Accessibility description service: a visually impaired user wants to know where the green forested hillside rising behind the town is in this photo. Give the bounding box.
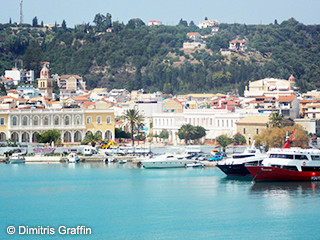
[0,14,320,94]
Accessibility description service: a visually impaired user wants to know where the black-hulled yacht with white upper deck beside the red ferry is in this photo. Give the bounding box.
[216,143,267,176]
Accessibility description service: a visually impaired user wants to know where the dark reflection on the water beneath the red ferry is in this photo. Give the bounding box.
[251,182,320,197]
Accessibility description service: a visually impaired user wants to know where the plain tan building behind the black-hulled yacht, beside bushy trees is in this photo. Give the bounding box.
[236,115,269,144]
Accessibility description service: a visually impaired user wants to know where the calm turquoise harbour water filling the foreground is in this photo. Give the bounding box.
[0,163,320,239]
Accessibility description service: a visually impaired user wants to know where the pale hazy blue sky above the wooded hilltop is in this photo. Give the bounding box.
[0,0,320,27]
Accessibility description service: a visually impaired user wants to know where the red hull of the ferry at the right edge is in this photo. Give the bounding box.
[246,166,320,181]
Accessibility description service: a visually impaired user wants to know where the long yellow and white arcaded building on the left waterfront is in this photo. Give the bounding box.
[0,108,114,143]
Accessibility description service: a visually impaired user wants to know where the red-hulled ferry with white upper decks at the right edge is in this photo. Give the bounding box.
[246,148,320,181]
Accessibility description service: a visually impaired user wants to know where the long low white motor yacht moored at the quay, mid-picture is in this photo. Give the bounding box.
[141,154,193,168]
